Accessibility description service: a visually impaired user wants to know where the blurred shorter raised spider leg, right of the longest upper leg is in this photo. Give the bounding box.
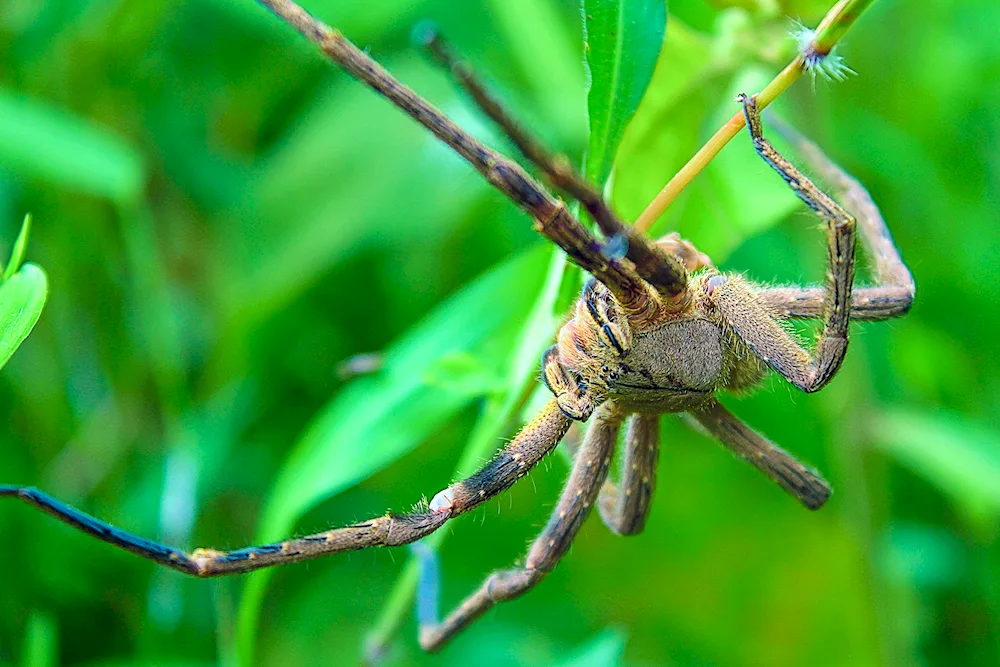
[418,24,687,297]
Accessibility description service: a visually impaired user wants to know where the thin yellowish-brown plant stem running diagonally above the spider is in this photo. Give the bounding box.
[635,0,874,232]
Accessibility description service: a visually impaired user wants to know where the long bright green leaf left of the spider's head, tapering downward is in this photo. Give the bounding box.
[237,246,550,662]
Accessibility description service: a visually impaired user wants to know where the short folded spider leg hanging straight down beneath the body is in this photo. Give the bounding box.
[597,414,660,535]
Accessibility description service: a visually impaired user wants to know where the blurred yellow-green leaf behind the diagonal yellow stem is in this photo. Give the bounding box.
[614,28,802,265]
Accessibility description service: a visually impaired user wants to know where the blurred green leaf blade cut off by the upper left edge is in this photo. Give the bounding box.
[0,89,145,201]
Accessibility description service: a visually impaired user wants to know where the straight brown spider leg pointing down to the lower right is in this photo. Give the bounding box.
[690,400,831,510]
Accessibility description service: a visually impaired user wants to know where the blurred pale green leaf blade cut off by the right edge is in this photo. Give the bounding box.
[872,410,1000,522]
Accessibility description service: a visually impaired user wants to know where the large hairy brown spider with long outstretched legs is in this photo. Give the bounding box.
[0,0,915,651]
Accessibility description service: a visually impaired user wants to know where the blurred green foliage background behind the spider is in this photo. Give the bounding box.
[0,0,1000,666]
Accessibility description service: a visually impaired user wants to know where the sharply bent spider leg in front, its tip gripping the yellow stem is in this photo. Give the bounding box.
[708,95,855,392]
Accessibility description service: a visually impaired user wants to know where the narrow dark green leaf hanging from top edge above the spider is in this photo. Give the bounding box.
[583,0,667,183]
